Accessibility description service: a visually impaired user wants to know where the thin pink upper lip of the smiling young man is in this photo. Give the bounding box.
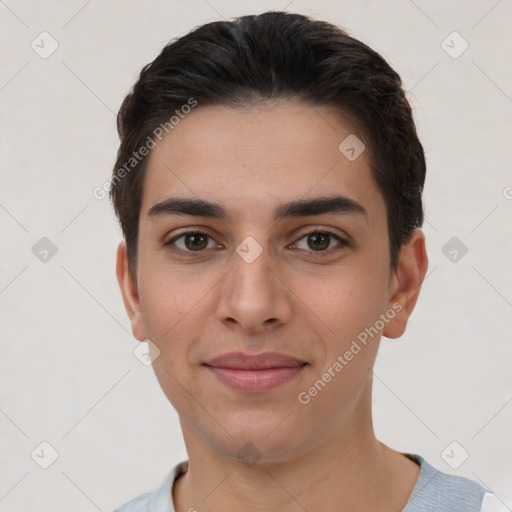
[205,352,305,370]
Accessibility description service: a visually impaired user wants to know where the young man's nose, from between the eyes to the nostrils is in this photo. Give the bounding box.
[217,243,292,335]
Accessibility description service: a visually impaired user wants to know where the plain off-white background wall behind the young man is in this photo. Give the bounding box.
[0,0,512,512]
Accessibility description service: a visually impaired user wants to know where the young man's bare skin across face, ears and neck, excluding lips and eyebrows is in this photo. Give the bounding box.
[117,101,427,512]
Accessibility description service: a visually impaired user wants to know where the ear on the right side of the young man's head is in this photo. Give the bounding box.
[382,229,428,338]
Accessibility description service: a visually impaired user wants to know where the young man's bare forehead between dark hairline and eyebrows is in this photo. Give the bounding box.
[141,101,385,224]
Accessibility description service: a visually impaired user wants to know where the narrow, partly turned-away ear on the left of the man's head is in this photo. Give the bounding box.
[116,240,147,341]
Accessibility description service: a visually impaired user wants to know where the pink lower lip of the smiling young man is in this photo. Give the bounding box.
[207,365,305,393]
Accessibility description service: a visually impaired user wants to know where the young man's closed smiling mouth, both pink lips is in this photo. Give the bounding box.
[204,352,308,393]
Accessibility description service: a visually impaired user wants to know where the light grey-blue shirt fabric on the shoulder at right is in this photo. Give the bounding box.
[403,455,487,512]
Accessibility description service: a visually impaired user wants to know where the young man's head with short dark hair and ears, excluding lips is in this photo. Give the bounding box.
[111,12,427,466]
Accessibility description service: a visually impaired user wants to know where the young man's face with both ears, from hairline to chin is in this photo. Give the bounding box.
[118,102,426,461]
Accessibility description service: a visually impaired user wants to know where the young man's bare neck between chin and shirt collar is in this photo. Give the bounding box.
[173,380,419,512]
